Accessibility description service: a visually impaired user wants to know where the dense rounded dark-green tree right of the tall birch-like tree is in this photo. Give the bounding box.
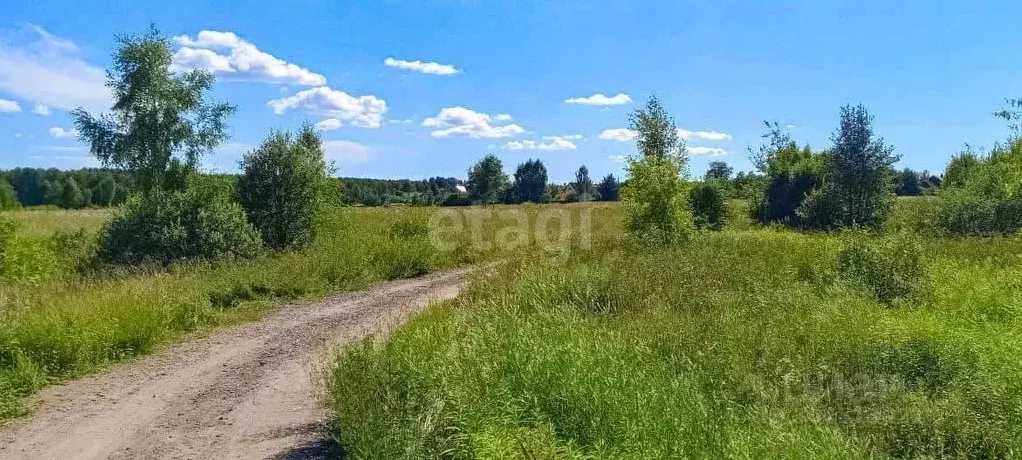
[238,125,327,249]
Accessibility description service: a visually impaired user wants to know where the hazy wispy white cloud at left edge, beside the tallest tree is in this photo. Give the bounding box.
[0,25,112,111]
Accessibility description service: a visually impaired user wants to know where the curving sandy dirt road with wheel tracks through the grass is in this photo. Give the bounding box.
[0,271,466,459]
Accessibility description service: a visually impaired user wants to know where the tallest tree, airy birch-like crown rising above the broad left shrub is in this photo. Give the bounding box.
[72,27,234,193]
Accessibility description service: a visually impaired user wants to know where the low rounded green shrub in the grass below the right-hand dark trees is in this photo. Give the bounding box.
[837,235,925,305]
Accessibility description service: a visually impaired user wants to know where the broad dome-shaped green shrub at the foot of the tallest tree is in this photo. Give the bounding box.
[99,182,262,265]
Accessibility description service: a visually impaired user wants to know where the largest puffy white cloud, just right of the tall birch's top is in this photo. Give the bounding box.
[173,31,326,86]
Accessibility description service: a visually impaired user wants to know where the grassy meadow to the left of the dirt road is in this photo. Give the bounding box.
[0,206,599,420]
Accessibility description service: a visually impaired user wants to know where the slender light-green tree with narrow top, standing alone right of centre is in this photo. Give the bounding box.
[621,97,692,245]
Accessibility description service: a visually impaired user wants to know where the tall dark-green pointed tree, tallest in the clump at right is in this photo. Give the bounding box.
[800,105,898,229]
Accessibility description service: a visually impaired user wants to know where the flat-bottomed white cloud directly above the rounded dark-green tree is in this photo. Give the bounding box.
[267,86,386,128]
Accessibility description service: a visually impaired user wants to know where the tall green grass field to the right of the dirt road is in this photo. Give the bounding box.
[329,201,1022,459]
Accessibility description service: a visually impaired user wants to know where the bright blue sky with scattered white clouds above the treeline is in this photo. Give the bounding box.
[0,0,1022,181]
